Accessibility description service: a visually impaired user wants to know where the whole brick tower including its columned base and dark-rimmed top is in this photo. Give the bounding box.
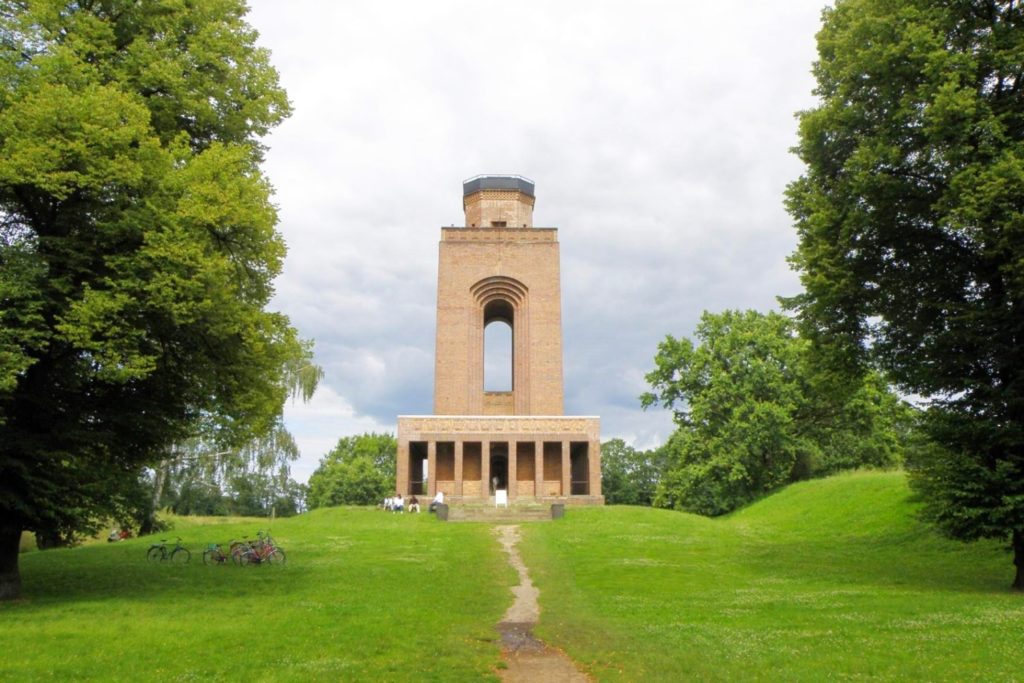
[396,175,603,504]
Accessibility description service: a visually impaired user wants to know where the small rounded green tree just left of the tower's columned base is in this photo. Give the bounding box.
[307,433,398,509]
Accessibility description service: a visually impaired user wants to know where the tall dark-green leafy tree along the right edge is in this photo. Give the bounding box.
[787,0,1024,589]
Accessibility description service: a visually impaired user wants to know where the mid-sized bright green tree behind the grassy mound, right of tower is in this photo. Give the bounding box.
[641,311,908,515]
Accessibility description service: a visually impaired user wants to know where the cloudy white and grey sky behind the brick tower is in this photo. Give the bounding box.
[249,0,825,481]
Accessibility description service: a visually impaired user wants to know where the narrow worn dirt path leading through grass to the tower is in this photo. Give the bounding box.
[495,524,590,683]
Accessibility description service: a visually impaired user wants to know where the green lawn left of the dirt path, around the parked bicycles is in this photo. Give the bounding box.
[0,508,515,682]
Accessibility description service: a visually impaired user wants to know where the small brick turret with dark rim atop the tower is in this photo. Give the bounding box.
[462,175,536,227]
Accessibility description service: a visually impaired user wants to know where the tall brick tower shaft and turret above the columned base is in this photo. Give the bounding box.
[434,171,562,415]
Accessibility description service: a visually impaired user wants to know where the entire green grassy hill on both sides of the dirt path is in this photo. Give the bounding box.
[0,473,1024,682]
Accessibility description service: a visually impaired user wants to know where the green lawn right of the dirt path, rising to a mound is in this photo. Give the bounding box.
[523,473,1024,681]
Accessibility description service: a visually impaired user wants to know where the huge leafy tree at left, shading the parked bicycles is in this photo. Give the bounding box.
[0,0,303,598]
